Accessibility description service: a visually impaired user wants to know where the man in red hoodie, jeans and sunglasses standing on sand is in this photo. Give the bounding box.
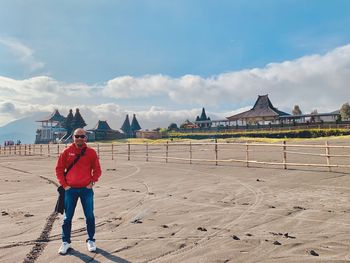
[56,129,101,255]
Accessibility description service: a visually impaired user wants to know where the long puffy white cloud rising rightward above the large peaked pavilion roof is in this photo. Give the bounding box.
[100,45,350,111]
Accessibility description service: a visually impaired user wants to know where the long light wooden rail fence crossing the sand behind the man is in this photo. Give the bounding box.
[0,141,350,171]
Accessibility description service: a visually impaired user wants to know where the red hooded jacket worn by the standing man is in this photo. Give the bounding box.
[56,143,101,188]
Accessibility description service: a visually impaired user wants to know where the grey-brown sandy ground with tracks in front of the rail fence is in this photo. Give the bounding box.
[0,141,350,263]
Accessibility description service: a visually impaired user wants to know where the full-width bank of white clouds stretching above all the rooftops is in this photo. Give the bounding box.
[0,45,350,129]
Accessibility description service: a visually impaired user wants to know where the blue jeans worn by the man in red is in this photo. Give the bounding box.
[62,187,95,243]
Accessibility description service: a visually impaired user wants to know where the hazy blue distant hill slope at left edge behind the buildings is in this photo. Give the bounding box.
[0,112,50,145]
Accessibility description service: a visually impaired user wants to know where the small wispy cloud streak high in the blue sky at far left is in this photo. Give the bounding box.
[0,37,45,72]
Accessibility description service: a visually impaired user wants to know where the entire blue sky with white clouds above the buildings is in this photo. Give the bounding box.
[0,0,350,129]
